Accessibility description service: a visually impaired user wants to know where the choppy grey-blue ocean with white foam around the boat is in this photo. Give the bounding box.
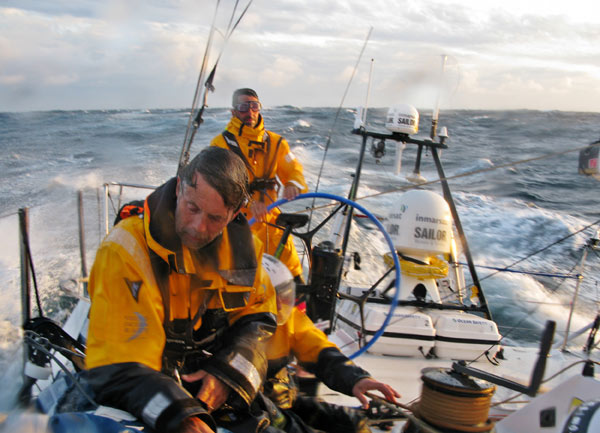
[0,106,600,408]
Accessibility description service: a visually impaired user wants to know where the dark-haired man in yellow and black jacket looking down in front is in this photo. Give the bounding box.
[86,148,276,433]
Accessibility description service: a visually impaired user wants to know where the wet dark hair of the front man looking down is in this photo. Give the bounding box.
[179,146,248,211]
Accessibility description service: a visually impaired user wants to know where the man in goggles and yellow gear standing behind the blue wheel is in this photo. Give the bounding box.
[210,88,308,277]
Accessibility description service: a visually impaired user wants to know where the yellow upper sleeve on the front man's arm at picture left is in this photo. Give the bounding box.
[85,228,166,370]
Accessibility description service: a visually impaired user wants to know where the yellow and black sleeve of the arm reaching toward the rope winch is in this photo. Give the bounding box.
[289,309,371,395]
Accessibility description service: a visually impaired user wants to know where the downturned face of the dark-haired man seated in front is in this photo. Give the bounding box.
[175,173,236,249]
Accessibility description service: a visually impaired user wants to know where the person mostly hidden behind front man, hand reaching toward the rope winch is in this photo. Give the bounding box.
[262,254,400,433]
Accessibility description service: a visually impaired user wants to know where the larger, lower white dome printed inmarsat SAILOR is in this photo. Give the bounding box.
[386,190,453,261]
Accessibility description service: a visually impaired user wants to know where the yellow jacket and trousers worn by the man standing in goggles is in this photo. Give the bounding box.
[210,115,308,276]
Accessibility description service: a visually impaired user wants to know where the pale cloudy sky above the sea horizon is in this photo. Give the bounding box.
[0,0,600,112]
